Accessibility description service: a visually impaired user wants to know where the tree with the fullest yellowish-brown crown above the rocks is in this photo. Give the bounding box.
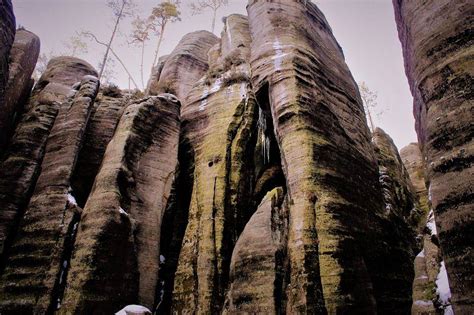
[149,0,181,71]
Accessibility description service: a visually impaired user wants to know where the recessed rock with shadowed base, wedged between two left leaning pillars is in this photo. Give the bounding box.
[71,92,129,207]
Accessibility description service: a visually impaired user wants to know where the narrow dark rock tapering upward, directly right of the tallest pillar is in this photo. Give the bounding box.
[372,128,424,314]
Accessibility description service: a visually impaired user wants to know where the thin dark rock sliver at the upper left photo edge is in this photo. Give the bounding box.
[0,0,16,142]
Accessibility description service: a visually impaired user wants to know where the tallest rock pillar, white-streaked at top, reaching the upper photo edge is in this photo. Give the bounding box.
[247,1,387,314]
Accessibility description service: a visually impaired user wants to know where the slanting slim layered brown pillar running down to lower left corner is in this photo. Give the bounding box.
[0,76,99,314]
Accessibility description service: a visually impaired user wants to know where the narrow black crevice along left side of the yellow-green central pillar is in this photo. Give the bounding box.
[154,137,194,314]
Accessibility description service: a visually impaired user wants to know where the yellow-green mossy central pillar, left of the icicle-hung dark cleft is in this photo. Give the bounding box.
[171,17,257,314]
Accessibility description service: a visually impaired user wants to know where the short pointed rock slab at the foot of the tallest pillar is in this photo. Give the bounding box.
[223,187,288,314]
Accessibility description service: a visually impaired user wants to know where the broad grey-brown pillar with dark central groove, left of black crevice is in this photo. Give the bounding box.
[60,94,179,314]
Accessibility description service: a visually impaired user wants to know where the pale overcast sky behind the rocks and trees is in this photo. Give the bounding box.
[13,0,416,149]
